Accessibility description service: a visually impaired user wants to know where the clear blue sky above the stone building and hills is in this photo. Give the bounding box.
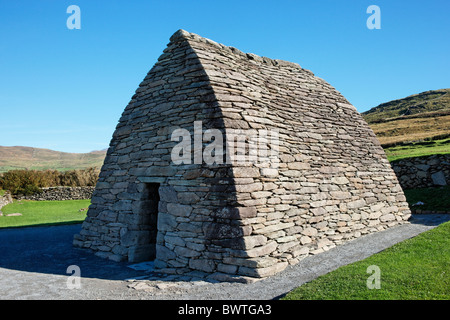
[0,0,450,152]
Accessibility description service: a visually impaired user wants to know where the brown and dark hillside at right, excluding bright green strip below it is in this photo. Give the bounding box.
[362,89,450,147]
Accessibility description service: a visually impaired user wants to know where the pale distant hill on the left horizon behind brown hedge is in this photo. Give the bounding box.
[0,146,106,172]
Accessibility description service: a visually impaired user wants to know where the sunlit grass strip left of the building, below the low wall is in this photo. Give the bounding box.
[0,200,91,228]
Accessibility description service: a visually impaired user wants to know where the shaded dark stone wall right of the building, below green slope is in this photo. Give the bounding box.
[391,154,450,189]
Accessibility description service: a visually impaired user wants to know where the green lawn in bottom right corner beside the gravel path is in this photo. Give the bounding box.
[283,222,450,300]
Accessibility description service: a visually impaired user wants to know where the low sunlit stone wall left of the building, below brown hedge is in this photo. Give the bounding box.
[16,187,95,201]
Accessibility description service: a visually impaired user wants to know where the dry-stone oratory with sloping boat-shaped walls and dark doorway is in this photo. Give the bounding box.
[73,30,410,281]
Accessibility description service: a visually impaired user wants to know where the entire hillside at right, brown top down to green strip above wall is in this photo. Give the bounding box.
[362,89,450,161]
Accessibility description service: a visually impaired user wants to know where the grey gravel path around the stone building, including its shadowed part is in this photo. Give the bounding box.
[0,215,450,300]
